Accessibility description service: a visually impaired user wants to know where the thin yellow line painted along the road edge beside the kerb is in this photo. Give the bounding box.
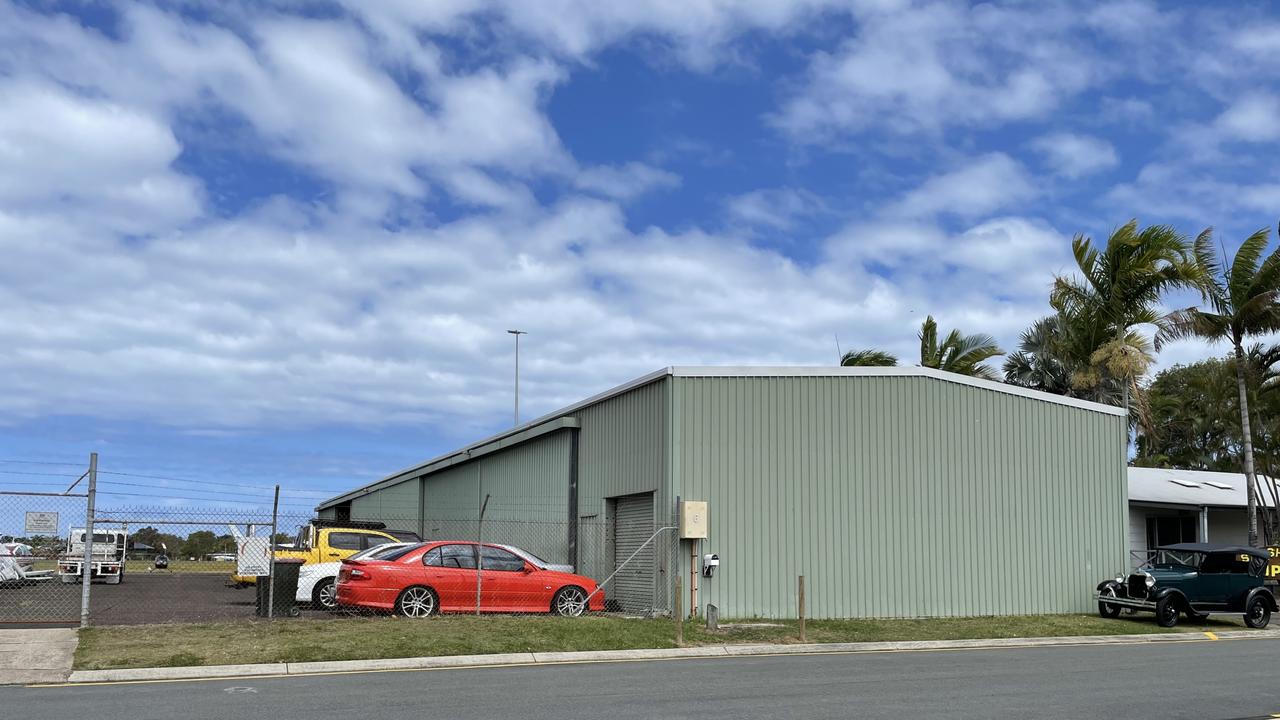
[32,637,1280,686]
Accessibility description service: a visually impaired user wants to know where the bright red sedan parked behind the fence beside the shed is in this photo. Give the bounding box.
[338,541,604,618]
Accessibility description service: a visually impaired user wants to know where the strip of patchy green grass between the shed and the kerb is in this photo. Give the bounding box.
[76,607,1243,670]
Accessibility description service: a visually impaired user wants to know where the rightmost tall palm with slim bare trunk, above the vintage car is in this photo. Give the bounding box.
[1156,228,1280,546]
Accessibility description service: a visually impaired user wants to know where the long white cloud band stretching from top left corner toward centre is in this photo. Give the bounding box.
[0,5,572,210]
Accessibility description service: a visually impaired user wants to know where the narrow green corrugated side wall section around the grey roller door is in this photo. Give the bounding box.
[573,378,673,593]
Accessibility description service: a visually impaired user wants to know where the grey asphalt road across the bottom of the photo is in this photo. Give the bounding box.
[0,639,1280,720]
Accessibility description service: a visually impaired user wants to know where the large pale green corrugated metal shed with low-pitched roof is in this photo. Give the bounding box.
[319,368,1126,618]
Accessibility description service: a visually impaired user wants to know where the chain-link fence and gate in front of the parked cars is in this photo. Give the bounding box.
[0,481,680,625]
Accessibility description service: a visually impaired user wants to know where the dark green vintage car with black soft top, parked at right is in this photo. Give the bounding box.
[1097,542,1280,628]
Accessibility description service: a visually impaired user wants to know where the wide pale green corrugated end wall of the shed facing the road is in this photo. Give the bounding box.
[673,377,1126,618]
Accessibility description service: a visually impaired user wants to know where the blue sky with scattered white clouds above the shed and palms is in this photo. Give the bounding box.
[0,0,1280,509]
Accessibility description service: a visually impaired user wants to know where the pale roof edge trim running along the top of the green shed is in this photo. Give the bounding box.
[316,365,1125,510]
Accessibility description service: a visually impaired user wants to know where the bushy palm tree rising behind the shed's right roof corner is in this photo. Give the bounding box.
[1050,215,1204,409]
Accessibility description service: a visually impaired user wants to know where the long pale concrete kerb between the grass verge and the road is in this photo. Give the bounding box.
[68,630,1280,683]
